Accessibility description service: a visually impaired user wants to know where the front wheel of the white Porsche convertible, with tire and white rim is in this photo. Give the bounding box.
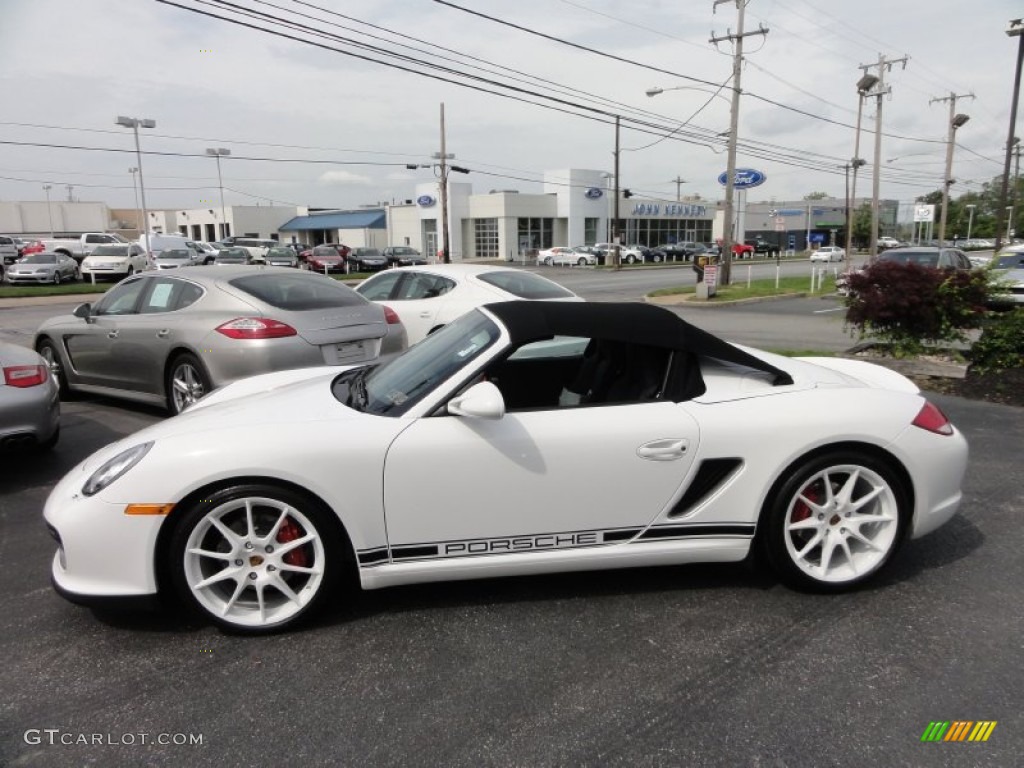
[169,484,348,634]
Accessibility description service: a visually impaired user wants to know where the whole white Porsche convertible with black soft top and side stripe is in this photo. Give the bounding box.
[44,302,968,633]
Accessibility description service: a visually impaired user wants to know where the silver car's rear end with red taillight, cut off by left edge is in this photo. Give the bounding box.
[0,341,60,453]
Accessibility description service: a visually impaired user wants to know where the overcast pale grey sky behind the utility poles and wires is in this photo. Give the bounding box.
[0,0,1024,217]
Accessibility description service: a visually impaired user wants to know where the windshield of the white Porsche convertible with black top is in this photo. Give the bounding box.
[346,310,501,416]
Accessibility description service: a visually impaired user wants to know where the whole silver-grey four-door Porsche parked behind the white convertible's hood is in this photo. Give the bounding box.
[34,266,408,414]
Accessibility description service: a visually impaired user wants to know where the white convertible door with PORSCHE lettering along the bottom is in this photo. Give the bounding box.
[384,401,699,561]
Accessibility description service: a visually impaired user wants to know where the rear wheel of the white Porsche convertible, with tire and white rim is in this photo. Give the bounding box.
[761,451,911,592]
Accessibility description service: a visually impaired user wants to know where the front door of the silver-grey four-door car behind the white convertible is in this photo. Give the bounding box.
[62,278,146,388]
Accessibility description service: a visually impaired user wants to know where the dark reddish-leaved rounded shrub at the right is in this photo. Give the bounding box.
[846,261,989,356]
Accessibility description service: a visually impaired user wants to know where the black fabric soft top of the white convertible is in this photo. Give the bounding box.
[486,301,793,386]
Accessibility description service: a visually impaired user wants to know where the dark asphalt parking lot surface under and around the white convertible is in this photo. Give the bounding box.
[0,278,1024,768]
